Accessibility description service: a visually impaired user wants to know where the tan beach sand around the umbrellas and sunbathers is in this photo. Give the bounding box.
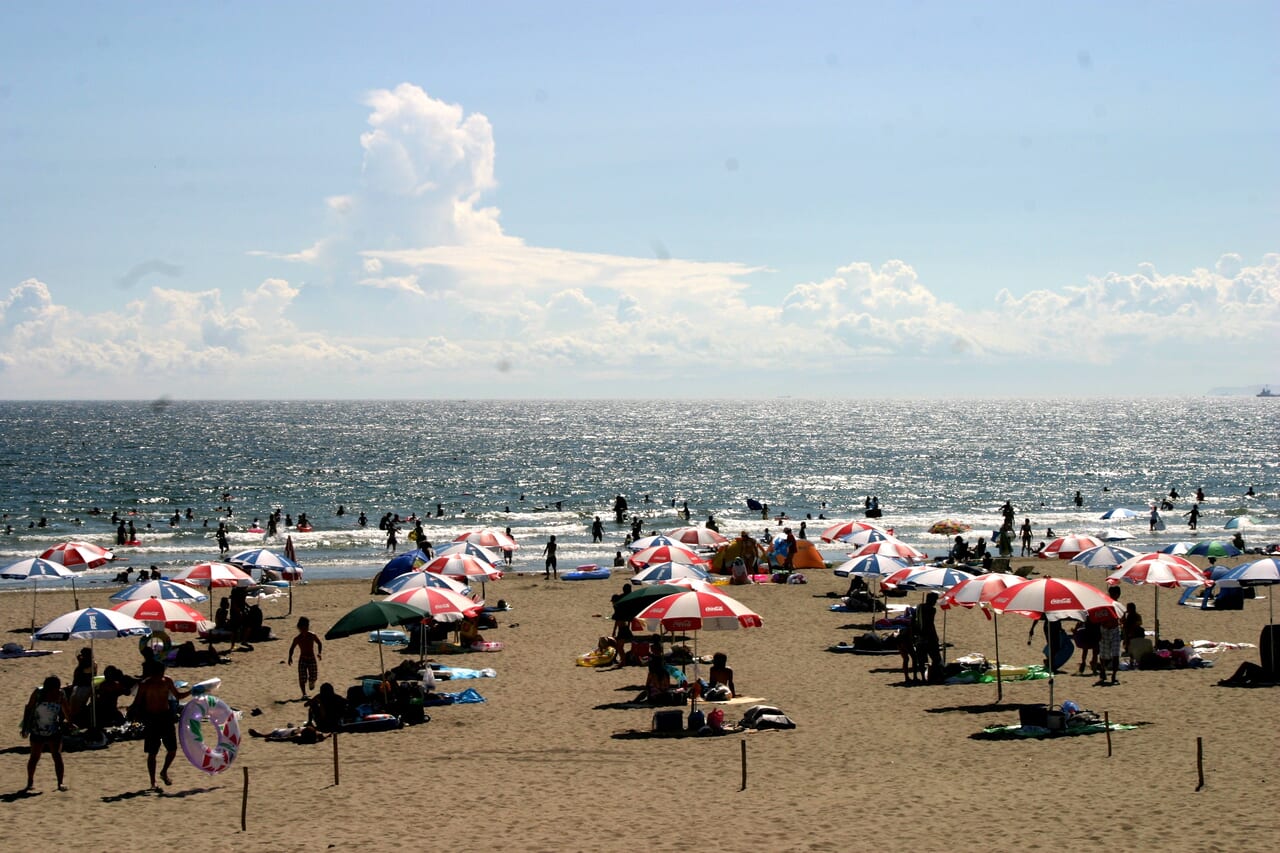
[0,561,1280,853]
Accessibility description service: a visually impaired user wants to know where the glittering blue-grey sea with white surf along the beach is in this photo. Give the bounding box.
[0,397,1280,589]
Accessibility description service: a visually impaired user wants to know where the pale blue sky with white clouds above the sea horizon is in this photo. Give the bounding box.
[0,0,1280,400]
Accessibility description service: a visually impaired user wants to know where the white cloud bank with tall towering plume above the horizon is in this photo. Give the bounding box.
[0,83,1280,398]
